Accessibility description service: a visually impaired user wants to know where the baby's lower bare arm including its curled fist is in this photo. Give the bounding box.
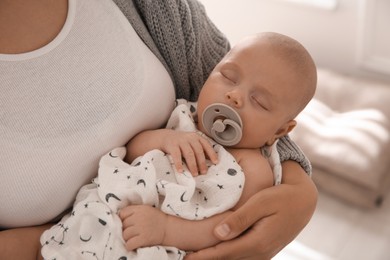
[119,205,231,251]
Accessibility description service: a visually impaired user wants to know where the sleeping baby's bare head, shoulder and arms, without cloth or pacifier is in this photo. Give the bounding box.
[120,32,317,250]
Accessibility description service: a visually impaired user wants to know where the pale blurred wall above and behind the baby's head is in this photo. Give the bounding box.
[201,0,390,82]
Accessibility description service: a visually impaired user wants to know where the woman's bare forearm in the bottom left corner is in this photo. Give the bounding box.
[0,224,52,260]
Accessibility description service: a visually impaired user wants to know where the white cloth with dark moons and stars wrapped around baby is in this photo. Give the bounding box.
[41,100,245,260]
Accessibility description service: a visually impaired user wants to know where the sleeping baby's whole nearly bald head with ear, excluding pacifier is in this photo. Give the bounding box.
[198,32,317,148]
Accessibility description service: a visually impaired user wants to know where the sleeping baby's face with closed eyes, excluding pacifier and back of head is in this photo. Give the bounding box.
[198,37,299,148]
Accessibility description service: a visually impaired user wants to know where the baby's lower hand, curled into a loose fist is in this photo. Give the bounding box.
[119,205,167,251]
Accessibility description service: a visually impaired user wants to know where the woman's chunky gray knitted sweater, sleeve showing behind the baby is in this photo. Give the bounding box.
[113,0,311,174]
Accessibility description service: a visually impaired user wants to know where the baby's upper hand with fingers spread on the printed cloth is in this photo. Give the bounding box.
[161,131,218,176]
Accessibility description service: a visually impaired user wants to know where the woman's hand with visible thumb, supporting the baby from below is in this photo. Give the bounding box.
[186,161,317,260]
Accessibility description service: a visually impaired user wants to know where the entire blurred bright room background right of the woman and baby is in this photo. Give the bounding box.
[201,0,390,260]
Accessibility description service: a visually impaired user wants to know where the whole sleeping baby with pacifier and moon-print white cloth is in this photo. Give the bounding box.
[41,32,316,259]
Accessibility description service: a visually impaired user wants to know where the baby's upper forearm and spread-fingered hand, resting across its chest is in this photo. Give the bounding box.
[125,129,218,176]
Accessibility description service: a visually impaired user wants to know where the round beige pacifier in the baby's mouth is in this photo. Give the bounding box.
[202,103,243,146]
